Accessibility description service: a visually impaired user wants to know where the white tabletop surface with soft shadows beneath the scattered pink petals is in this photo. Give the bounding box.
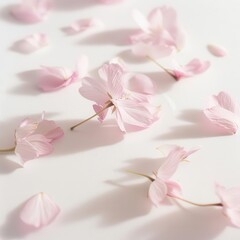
[0,0,240,240]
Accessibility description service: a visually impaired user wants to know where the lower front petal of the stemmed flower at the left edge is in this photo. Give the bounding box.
[15,134,53,164]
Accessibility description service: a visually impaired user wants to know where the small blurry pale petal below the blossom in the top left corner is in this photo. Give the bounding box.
[14,33,48,53]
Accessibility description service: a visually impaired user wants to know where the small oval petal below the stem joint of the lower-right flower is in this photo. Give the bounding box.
[148,178,167,207]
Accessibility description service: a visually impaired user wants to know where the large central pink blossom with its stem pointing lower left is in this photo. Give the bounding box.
[71,63,159,132]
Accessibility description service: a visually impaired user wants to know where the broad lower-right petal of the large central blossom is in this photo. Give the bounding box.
[112,100,159,132]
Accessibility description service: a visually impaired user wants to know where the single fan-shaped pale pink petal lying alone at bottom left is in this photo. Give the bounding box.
[20,193,60,228]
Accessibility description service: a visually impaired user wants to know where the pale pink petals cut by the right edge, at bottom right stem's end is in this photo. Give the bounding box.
[215,185,240,228]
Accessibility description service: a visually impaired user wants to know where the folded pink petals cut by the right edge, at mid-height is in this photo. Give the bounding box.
[204,92,240,134]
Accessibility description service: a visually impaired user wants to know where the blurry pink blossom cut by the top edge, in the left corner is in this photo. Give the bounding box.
[11,0,51,23]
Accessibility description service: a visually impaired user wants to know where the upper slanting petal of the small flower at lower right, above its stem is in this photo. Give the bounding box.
[157,146,199,180]
